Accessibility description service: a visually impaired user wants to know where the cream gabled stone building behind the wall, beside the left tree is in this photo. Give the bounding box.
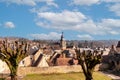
[19,49,49,67]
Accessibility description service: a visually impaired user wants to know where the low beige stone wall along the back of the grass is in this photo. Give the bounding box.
[18,64,106,76]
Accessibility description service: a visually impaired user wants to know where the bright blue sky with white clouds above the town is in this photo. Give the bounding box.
[0,0,120,40]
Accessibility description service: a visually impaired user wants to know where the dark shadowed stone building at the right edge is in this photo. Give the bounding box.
[103,41,120,72]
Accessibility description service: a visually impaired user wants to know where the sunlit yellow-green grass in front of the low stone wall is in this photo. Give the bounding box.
[23,72,112,80]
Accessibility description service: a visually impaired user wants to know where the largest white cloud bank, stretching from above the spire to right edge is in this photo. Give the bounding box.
[36,11,120,35]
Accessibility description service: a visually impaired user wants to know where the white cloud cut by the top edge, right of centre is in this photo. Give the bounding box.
[71,0,100,6]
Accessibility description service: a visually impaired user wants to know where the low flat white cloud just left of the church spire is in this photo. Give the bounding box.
[30,32,61,40]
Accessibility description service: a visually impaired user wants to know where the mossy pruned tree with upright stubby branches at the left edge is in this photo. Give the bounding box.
[0,40,30,80]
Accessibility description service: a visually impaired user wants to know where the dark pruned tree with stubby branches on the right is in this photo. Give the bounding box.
[75,49,103,80]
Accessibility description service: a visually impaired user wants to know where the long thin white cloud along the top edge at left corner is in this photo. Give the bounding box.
[0,0,58,7]
